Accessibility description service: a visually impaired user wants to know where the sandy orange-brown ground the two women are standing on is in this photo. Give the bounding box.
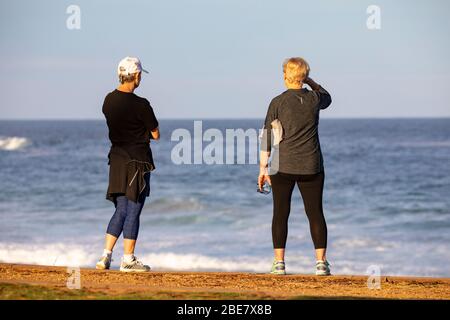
[0,264,450,300]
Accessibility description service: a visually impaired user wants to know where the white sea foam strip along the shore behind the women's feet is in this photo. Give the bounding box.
[0,243,445,276]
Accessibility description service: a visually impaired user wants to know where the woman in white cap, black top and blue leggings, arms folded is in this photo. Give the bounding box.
[96,57,159,272]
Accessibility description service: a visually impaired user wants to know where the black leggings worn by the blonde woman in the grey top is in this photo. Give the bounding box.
[270,171,327,249]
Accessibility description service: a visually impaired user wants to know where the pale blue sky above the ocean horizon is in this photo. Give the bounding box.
[0,0,450,119]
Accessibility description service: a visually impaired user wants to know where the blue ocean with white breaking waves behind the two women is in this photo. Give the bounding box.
[0,118,450,277]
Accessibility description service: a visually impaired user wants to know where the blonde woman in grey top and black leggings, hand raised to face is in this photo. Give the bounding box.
[258,58,331,275]
